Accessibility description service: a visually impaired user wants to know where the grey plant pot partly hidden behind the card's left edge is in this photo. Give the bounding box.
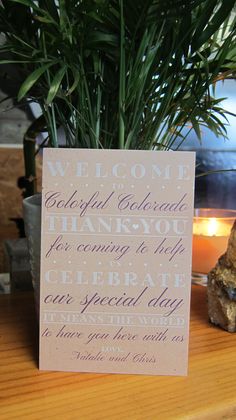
[23,194,42,315]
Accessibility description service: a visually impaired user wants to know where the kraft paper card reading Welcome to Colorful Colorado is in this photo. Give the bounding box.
[40,149,195,375]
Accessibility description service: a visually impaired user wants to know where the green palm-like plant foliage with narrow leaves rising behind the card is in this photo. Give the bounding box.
[0,0,236,302]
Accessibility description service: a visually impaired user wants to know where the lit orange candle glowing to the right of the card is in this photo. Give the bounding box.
[192,209,236,273]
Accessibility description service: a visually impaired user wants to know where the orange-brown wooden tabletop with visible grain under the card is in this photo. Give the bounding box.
[0,286,236,420]
